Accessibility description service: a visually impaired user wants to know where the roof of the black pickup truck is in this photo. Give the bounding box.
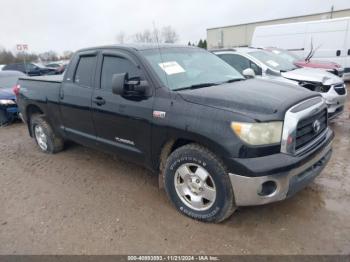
[77,43,198,52]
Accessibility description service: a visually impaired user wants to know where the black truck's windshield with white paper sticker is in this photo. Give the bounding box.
[141,48,244,90]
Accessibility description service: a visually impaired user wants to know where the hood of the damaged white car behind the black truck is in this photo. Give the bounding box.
[281,67,343,85]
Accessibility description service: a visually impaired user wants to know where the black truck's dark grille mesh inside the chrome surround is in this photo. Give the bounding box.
[295,109,327,151]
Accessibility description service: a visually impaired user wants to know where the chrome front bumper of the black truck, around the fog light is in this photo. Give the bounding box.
[229,142,332,206]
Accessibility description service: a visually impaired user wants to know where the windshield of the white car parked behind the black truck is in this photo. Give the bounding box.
[249,50,297,72]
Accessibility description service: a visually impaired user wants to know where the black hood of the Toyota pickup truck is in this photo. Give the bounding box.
[178,79,319,121]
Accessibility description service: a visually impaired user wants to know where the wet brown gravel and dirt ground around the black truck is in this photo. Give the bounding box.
[0,84,350,254]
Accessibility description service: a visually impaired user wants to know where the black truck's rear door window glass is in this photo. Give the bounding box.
[74,56,96,86]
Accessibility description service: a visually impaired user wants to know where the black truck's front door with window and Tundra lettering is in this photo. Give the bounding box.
[92,51,153,163]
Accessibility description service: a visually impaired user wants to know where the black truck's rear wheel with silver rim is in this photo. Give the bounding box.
[30,115,64,154]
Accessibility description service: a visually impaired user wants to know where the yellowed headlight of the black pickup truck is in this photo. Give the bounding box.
[231,122,283,146]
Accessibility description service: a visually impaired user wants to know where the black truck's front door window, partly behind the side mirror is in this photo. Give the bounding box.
[101,56,142,90]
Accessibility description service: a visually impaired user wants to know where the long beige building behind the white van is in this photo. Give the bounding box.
[207,9,350,49]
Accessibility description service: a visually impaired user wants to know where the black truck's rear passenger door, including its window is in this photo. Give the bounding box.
[60,52,97,145]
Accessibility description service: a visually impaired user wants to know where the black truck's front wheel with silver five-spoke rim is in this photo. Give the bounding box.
[164,144,236,223]
